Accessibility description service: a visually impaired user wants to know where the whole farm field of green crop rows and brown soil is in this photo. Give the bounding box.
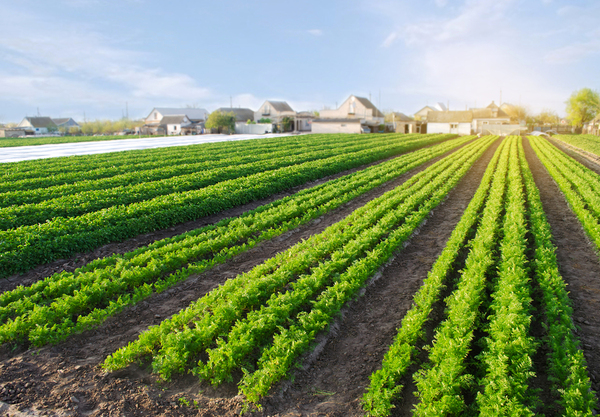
[0,135,600,416]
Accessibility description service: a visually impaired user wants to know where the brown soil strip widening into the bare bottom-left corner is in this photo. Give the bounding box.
[0,141,474,416]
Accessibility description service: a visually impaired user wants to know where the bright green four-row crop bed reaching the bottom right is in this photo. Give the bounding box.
[363,137,596,416]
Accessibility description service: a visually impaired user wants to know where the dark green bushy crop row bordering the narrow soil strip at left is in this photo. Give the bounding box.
[0,133,452,278]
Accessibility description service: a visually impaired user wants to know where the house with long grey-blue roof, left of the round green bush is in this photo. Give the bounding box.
[140,107,208,135]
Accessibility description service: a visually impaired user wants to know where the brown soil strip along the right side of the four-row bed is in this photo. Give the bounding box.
[523,140,600,402]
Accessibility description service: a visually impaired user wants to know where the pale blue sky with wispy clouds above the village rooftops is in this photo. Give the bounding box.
[0,0,600,123]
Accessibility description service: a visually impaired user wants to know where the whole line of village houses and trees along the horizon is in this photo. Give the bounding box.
[0,88,600,138]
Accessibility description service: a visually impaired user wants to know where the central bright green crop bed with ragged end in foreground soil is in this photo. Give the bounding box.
[104,138,495,401]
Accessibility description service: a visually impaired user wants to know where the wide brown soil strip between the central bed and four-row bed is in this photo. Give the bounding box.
[255,140,500,416]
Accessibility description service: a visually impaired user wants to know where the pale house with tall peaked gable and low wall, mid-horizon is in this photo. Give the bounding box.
[312,95,384,133]
